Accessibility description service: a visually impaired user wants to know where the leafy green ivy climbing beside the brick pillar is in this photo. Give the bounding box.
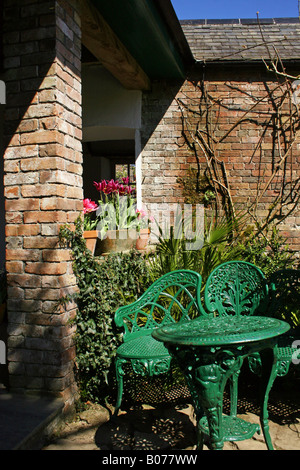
[60,219,148,402]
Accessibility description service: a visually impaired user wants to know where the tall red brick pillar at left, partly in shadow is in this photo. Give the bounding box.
[4,0,82,399]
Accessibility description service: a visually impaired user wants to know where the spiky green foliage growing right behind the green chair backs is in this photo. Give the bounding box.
[149,210,295,288]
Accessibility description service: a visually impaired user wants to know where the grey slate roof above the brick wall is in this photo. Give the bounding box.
[180,18,300,62]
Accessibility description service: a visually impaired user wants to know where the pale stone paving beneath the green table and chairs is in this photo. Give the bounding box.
[43,382,300,452]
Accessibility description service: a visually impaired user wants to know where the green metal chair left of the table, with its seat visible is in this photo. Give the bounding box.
[114,270,205,414]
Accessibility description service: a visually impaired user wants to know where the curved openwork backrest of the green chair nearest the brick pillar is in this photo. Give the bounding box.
[114,270,205,341]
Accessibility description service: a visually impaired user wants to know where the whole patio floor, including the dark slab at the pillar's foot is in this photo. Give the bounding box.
[0,376,300,452]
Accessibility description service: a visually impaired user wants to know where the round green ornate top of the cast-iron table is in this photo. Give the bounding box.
[152,315,290,346]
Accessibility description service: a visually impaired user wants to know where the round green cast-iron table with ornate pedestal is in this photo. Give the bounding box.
[152,316,290,450]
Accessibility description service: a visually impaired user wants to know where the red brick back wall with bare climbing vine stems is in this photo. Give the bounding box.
[142,69,300,251]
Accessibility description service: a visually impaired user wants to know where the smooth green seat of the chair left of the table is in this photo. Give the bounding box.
[117,334,170,359]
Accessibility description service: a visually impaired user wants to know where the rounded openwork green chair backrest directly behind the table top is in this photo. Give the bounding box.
[204,261,268,316]
